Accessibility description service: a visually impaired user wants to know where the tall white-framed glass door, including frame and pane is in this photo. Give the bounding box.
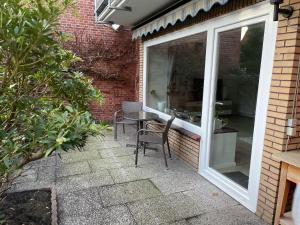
[200,8,276,212]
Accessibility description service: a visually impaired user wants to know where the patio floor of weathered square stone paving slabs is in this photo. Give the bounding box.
[10,128,264,225]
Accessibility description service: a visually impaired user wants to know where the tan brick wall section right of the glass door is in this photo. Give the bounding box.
[257,0,300,223]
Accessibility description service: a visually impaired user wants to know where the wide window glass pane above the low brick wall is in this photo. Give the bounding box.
[146,33,206,126]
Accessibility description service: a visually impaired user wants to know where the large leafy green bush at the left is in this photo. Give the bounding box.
[0,0,106,184]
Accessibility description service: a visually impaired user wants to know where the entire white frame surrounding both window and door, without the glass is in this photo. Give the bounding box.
[143,2,277,212]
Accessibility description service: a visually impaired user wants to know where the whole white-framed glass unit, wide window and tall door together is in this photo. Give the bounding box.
[143,3,276,211]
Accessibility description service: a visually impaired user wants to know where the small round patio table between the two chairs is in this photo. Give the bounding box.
[124,111,159,147]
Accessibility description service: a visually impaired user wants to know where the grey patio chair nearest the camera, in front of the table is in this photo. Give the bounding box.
[135,116,175,168]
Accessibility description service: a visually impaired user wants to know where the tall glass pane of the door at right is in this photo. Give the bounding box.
[210,23,264,188]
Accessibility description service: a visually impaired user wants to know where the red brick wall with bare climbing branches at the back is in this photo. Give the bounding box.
[60,0,137,120]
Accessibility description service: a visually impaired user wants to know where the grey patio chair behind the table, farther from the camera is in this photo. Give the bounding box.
[113,101,143,140]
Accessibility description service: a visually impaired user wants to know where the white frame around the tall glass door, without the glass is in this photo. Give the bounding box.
[199,3,277,212]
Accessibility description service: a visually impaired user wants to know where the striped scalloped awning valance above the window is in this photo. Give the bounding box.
[132,0,229,39]
